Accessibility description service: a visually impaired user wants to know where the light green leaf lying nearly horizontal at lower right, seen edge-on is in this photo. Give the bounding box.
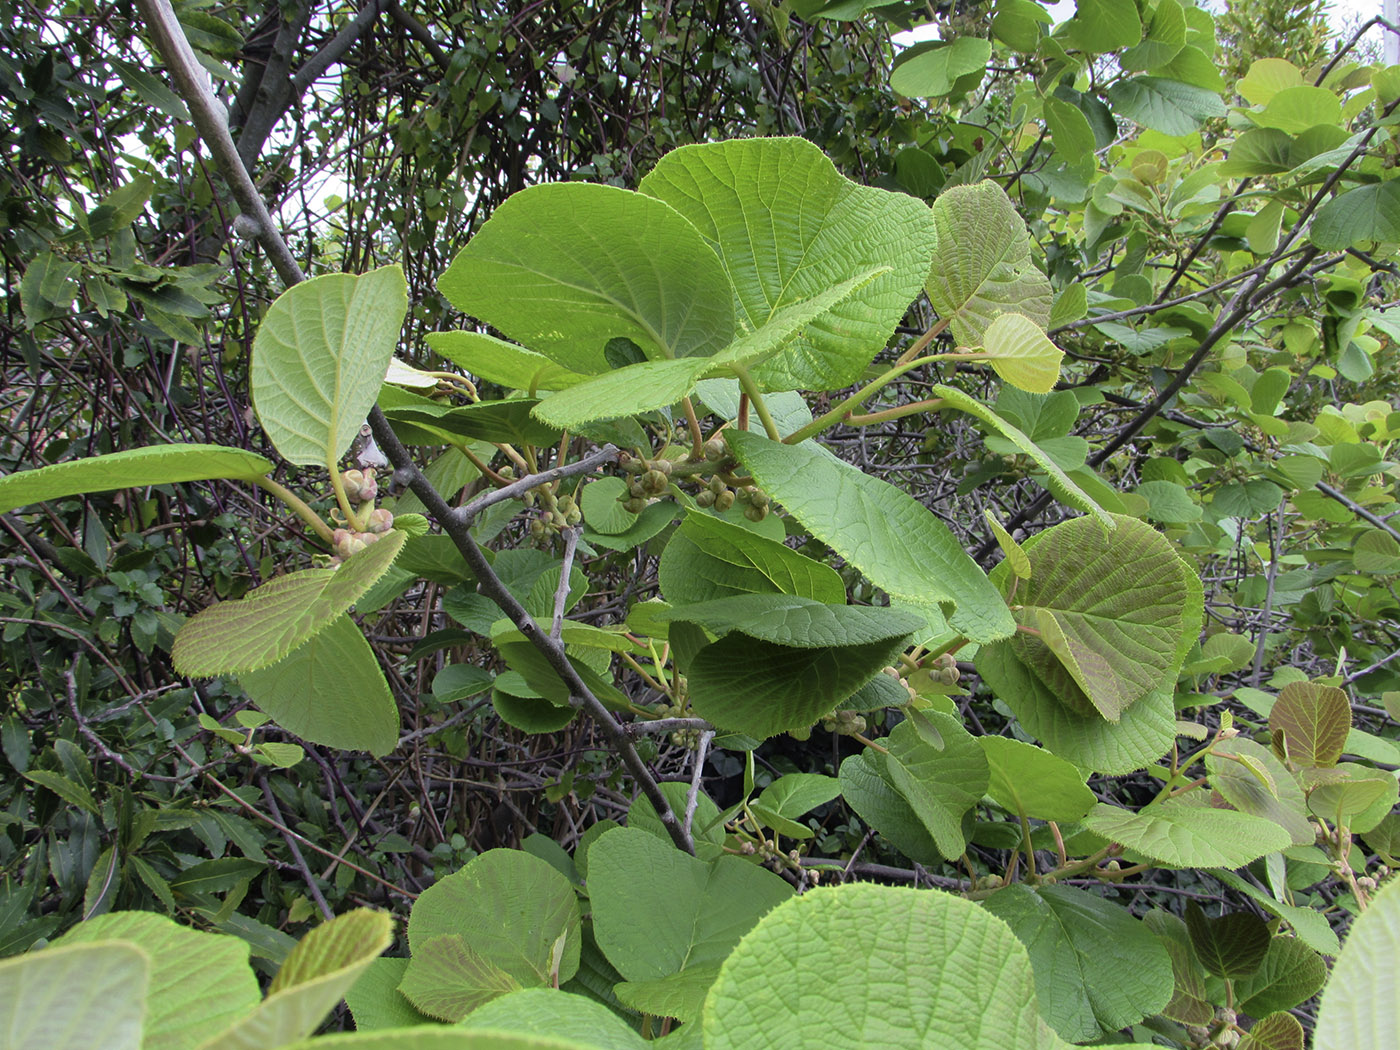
[1084,801,1291,868]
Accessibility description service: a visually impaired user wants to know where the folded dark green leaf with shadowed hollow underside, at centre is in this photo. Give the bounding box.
[666,594,921,738]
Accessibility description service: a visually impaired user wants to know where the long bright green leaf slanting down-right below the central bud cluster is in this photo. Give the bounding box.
[727,431,1015,643]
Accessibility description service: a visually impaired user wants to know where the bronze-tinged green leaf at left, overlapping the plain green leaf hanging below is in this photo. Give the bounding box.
[171,531,407,677]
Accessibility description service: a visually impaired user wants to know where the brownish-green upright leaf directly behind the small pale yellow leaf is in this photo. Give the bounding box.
[927,181,1054,346]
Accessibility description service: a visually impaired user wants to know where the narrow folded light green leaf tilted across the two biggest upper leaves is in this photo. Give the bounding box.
[535,266,889,428]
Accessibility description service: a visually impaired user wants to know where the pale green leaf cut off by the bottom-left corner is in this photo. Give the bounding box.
[0,941,151,1050]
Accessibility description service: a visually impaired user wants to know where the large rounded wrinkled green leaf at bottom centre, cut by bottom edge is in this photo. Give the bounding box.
[701,883,1063,1050]
